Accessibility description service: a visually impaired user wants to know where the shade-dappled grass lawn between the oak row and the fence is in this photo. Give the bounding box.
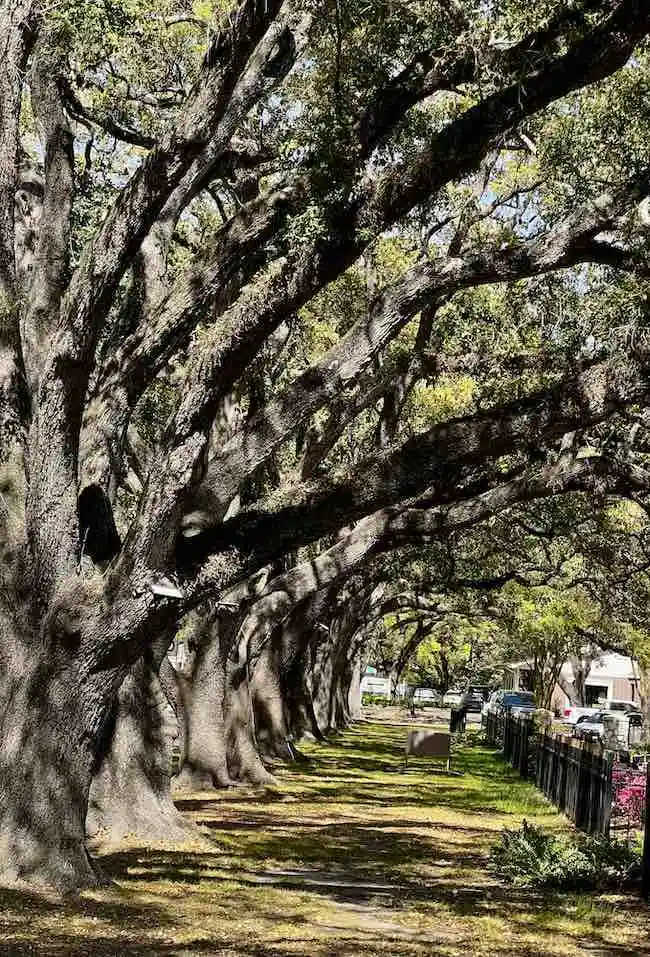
[0,723,650,957]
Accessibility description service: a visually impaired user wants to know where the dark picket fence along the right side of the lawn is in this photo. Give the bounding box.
[486,714,614,834]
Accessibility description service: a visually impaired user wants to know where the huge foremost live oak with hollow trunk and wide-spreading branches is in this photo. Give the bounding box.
[0,0,650,889]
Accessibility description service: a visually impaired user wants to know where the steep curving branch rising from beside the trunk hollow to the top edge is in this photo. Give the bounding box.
[29,0,302,593]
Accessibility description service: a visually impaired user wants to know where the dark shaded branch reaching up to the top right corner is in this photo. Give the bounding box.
[170,0,650,474]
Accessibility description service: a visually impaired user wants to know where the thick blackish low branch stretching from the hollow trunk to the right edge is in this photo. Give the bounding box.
[178,352,650,564]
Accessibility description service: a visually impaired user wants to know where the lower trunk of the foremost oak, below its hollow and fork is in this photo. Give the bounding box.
[0,617,112,891]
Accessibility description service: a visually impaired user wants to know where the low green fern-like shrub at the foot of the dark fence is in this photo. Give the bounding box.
[490,821,641,889]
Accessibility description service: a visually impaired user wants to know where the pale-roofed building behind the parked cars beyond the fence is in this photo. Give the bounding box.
[504,651,640,711]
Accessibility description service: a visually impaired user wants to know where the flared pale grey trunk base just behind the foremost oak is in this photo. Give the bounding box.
[86,660,185,843]
